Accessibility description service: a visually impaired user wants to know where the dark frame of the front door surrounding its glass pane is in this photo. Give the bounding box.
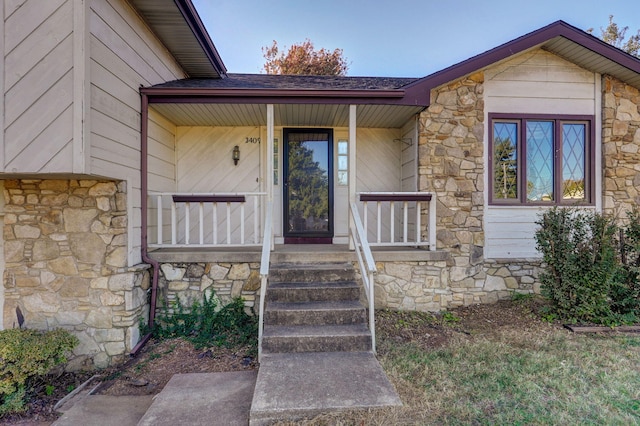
[282,127,335,244]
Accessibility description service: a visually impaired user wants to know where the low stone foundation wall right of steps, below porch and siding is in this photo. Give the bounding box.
[370,259,540,312]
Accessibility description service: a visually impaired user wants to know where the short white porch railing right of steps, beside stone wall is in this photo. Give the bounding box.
[359,192,436,250]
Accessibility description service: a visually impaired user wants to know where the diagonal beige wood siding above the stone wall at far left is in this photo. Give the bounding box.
[0,0,73,173]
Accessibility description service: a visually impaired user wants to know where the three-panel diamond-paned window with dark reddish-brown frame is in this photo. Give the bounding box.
[489,114,594,205]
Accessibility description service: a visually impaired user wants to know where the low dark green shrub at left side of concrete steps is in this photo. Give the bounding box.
[152,291,258,351]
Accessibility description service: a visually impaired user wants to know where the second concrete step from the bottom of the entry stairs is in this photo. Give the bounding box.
[264,300,367,328]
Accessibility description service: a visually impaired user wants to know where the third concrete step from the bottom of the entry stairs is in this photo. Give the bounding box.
[266,281,360,302]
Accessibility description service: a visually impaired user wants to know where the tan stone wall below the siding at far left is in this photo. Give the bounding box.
[3,179,150,368]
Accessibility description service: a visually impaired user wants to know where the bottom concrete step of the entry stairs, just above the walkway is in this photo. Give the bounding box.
[262,324,371,354]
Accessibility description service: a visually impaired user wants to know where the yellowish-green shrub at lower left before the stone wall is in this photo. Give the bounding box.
[0,328,78,415]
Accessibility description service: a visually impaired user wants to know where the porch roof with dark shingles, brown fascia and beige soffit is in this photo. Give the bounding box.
[141,74,426,128]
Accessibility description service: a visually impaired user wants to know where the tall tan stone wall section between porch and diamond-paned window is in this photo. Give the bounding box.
[418,73,485,302]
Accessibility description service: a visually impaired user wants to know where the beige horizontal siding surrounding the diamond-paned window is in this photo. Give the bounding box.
[484,50,600,259]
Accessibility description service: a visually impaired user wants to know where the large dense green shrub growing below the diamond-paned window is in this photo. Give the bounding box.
[535,207,640,326]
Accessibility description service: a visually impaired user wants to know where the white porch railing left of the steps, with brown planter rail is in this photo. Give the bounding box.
[149,192,267,248]
